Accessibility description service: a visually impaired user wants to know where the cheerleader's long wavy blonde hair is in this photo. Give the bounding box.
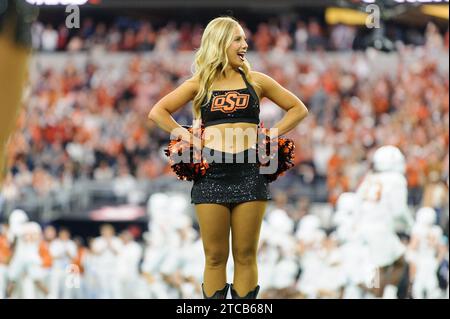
[193,17,257,122]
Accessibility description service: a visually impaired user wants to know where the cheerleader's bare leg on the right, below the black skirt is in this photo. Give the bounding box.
[231,201,267,296]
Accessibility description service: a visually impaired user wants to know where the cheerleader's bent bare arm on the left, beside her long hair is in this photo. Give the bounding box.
[148,78,198,142]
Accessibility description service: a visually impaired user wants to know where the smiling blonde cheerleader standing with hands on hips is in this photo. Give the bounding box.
[149,17,308,299]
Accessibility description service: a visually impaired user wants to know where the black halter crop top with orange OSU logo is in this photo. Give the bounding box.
[201,70,259,127]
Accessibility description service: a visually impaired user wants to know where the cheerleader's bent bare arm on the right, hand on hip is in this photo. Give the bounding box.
[252,72,308,137]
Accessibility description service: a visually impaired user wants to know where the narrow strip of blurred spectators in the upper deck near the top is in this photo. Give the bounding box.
[32,16,449,52]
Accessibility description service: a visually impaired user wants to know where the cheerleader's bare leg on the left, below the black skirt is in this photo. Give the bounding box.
[195,204,230,297]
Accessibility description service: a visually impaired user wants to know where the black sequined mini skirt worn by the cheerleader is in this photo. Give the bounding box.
[191,147,272,204]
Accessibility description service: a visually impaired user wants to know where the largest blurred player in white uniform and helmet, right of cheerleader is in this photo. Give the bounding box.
[356,145,413,298]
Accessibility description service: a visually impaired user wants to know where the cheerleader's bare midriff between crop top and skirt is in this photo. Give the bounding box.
[204,123,258,153]
